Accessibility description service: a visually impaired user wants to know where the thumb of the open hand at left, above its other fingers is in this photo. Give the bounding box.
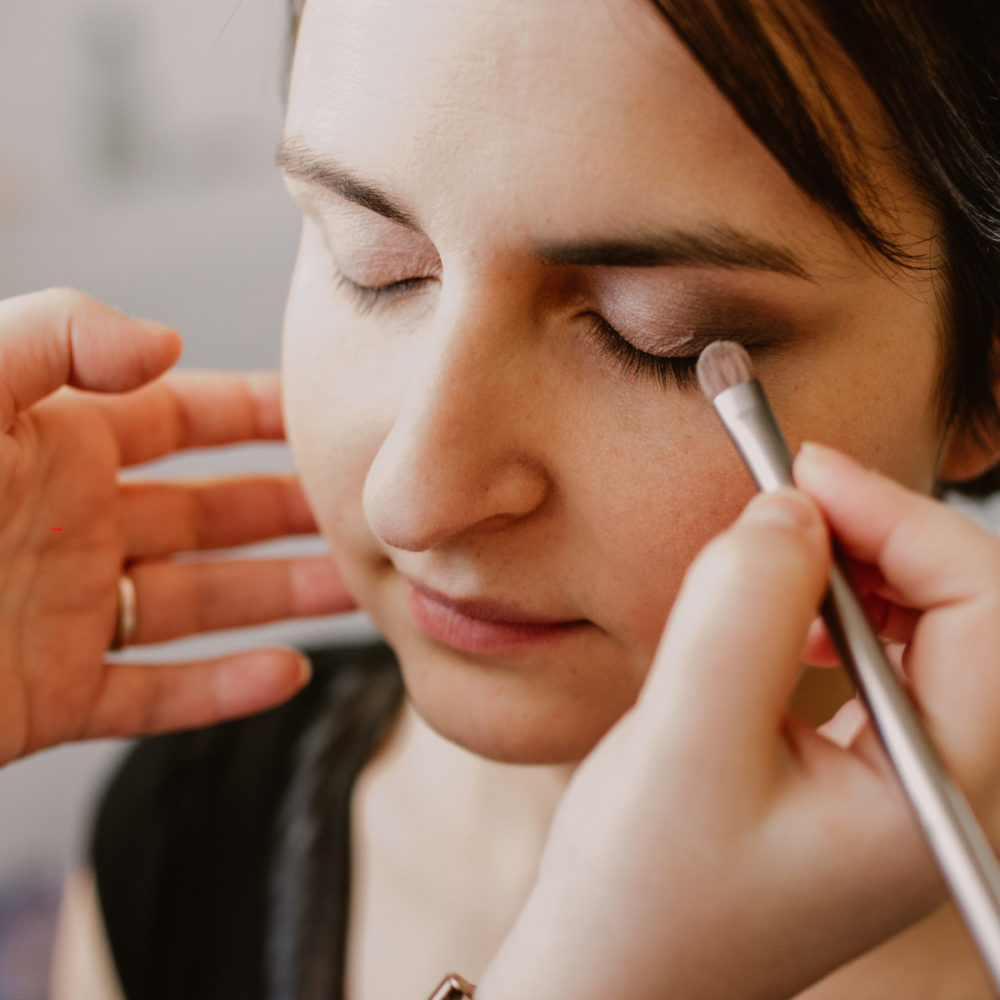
[0,289,181,431]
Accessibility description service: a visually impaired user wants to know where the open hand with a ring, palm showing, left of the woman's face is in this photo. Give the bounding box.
[0,290,351,764]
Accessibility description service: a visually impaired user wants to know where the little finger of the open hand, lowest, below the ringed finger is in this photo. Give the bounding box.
[80,649,309,739]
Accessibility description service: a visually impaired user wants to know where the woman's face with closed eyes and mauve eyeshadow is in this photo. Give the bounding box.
[282,0,960,761]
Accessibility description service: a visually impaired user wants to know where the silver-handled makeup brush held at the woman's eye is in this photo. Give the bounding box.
[698,341,1000,996]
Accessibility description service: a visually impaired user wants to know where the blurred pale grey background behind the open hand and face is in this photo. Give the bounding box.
[0,0,365,1000]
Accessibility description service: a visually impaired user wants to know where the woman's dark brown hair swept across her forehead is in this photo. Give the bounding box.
[289,0,1000,492]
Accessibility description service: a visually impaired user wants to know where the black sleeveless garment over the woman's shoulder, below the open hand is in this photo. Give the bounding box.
[91,646,402,1000]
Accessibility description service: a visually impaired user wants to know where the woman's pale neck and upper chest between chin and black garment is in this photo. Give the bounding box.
[348,703,572,998]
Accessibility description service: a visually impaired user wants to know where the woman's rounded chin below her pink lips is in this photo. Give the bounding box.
[394,643,637,764]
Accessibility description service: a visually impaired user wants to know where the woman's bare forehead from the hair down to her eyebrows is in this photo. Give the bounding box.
[286,0,828,241]
